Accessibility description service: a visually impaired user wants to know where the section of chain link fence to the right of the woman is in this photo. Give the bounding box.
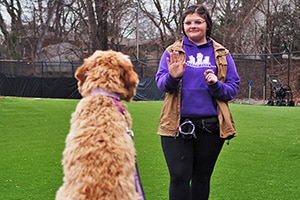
[233,51,300,103]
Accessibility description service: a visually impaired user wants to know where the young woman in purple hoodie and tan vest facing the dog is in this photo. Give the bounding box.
[156,5,240,200]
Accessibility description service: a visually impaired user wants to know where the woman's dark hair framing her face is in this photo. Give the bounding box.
[181,5,212,38]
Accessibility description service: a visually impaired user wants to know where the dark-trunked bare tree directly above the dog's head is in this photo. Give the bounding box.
[69,0,132,54]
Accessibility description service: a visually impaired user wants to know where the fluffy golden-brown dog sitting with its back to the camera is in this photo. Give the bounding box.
[56,50,139,200]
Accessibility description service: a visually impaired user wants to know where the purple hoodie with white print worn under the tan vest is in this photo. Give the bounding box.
[156,36,240,117]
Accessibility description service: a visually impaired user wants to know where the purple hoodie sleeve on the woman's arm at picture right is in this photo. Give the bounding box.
[208,53,240,101]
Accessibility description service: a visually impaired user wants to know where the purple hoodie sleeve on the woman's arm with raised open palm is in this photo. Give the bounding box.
[155,51,180,93]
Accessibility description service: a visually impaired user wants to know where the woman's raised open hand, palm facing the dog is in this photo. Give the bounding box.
[167,51,185,78]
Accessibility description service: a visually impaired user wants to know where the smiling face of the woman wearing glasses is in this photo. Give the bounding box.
[183,13,207,45]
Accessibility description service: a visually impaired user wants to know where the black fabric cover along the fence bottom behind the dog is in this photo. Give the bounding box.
[0,74,164,101]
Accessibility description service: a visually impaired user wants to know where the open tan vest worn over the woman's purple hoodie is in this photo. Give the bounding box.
[157,39,236,139]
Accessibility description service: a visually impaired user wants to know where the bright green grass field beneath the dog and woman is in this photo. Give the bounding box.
[0,98,300,200]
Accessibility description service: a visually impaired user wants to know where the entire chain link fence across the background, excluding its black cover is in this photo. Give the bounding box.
[0,51,300,103]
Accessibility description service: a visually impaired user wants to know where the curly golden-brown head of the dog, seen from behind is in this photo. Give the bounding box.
[75,50,139,101]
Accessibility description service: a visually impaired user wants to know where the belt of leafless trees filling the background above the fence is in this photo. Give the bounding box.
[0,0,300,60]
